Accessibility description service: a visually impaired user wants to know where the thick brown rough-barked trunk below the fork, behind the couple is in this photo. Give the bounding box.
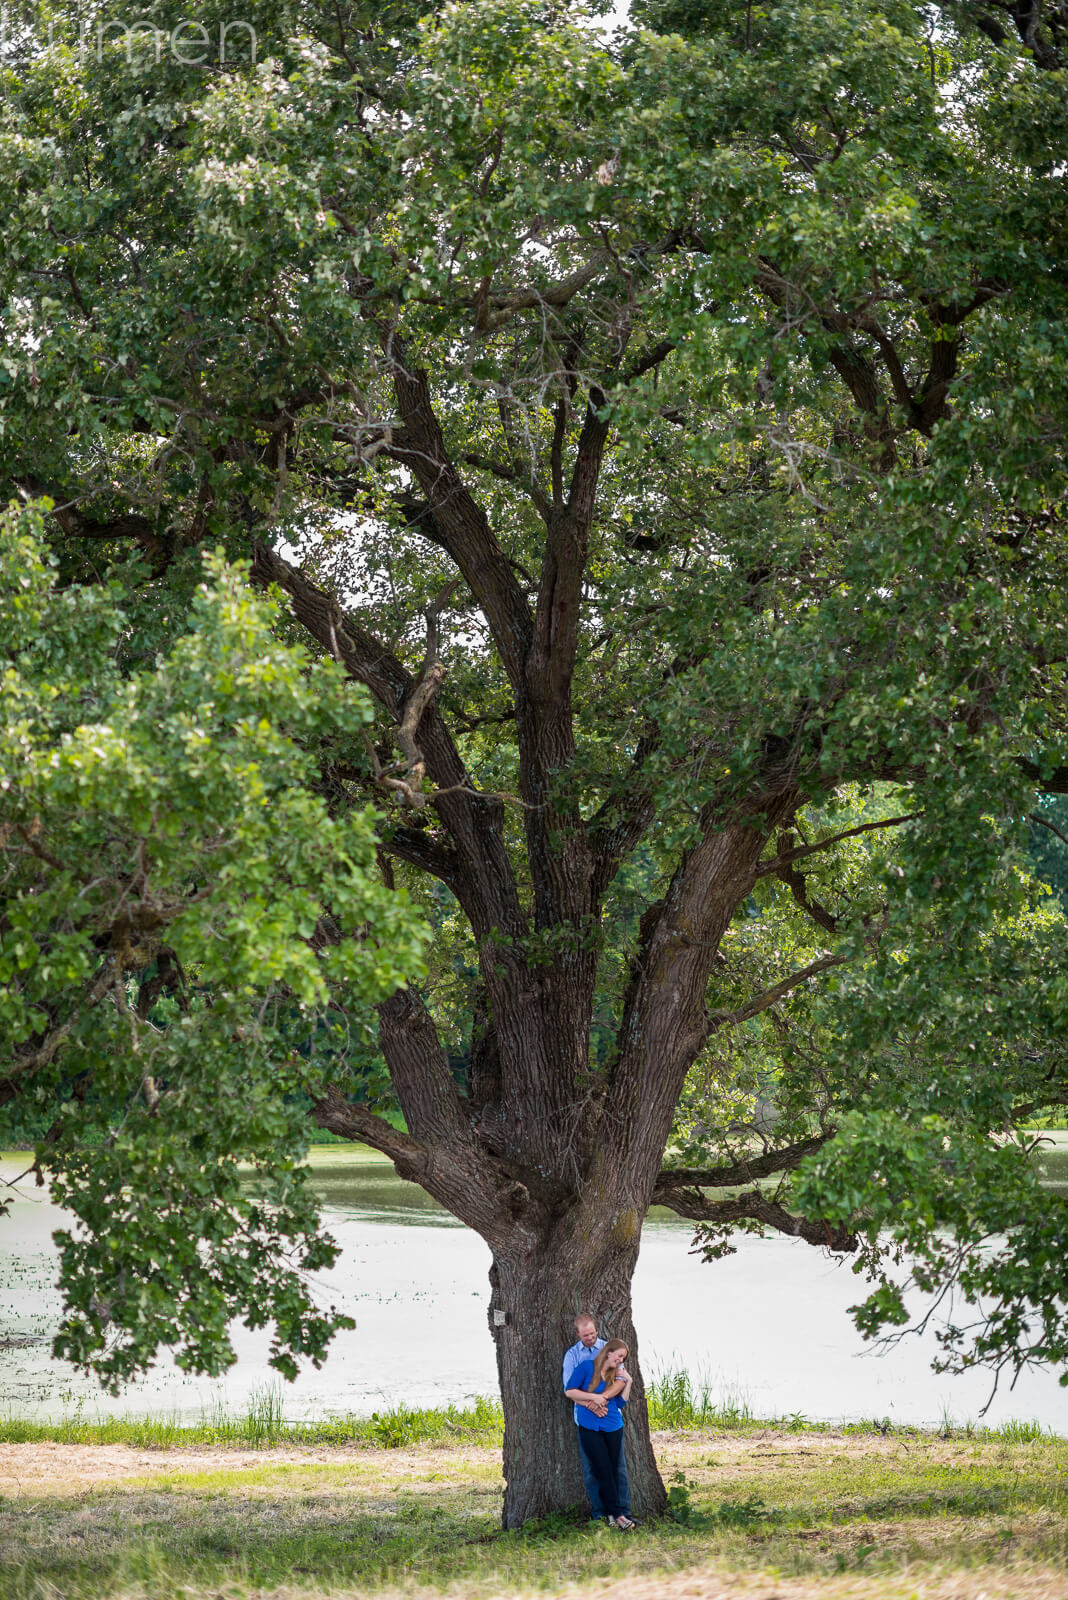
[489,1208,667,1528]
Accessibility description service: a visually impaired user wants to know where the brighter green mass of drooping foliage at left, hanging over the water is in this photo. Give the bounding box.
[0,510,425,1386]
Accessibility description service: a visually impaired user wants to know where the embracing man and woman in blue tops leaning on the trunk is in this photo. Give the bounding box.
[564,1312,635,1533]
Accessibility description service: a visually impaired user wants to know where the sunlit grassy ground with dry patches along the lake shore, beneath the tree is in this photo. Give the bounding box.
[0,1422,1068,1600]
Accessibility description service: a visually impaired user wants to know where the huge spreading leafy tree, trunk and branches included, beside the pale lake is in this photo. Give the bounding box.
[0,0,1068,1522]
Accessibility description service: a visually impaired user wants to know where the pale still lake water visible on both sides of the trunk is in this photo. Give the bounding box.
[0,1134,1068,1435]
